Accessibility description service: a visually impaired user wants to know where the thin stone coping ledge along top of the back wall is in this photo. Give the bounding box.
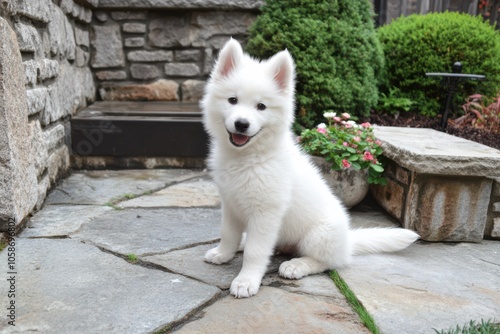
[95,0,264,9]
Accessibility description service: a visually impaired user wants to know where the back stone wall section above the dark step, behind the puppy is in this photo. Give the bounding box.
[90,0,262,101]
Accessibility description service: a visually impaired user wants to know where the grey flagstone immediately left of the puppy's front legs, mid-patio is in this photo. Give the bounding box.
[72,208,221,256]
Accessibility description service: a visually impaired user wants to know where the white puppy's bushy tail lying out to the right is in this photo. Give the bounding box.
[351,227,419,255]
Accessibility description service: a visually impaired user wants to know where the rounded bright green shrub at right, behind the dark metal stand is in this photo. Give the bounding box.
[378,12,500,116]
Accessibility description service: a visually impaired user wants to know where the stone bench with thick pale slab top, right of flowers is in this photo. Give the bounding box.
[372,127,500,242]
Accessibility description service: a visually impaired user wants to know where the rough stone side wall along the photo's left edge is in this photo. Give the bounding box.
[0,0,98,230]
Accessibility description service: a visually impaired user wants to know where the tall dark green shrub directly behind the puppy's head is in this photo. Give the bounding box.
[246,0,384,127]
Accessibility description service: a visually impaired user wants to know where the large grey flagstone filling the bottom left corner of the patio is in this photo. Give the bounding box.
[0,238,220,334]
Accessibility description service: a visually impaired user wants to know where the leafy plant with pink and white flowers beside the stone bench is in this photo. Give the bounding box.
[300,112,386,184]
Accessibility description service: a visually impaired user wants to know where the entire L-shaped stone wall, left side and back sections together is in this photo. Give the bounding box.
[0,0,263,231]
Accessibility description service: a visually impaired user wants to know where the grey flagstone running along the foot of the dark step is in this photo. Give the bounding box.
[47,169,205,205]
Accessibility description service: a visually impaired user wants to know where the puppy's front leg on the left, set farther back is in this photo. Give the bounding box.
[205,206,244,264]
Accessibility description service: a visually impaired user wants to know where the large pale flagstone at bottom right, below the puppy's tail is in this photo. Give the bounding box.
[339,241,500,334]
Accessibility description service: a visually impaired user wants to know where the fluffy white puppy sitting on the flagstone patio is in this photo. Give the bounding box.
[201,39,418,298]
